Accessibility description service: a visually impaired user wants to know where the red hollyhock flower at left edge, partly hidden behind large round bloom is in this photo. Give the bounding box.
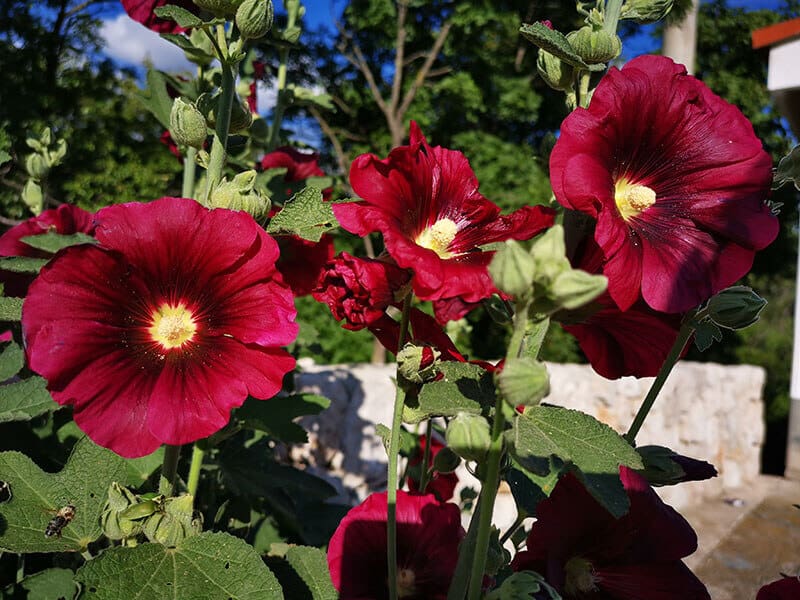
[0,204,94,297]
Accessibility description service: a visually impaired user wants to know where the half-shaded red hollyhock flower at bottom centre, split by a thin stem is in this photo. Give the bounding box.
[328,490,465,600]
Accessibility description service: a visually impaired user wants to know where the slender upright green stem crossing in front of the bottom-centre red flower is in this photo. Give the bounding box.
[386,294,412,600]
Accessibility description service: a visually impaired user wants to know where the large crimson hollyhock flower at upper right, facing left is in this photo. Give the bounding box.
[550,56,778,313]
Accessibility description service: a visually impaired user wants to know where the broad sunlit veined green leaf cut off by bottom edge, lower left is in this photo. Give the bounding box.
[75,532,283,600]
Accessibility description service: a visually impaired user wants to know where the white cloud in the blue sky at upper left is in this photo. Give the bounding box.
[100,13,194,73]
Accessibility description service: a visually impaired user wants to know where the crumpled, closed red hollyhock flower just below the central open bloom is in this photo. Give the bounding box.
[312,252,410,331]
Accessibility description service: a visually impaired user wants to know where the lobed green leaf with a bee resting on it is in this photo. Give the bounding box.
[0,438,125,554]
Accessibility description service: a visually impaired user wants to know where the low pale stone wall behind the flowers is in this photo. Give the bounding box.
[292,361,765,521]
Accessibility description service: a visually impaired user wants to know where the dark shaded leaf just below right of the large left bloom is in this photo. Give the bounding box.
[234,394,331,444]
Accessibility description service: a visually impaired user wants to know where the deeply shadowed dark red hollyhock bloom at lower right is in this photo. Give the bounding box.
[511,467,710,600]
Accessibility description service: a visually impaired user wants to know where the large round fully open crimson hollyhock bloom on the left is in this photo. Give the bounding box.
[22,198,297,457]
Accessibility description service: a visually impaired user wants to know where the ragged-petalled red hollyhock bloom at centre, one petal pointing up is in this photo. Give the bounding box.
[333,122,554,302]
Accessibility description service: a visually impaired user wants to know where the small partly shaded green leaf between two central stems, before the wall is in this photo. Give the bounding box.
[404,361,495,423]
